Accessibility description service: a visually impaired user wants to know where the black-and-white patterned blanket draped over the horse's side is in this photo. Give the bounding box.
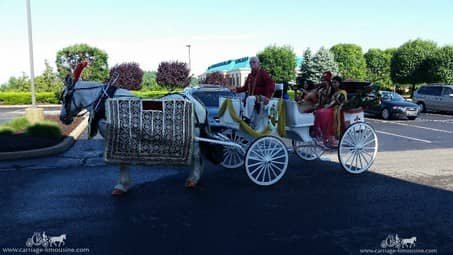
[104,99,194,165]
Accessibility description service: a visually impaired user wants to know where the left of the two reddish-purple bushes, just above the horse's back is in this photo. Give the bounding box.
[109,63,143,90]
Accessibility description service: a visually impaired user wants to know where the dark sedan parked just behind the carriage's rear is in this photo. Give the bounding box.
[365,91,419,120]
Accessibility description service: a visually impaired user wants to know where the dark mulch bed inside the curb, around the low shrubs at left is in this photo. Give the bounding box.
[0,115,82,152]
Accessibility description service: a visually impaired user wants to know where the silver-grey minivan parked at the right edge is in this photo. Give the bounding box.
[413,84,453,112]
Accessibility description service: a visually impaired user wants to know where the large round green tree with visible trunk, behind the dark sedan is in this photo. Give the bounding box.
[390,39,437,95]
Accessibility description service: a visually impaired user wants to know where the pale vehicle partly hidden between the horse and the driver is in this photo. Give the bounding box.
[185,84,236,130]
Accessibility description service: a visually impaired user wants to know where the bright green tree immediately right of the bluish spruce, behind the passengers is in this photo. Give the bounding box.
[330,44,366,80]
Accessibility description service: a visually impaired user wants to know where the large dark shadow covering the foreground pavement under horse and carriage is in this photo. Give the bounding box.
[0,157,453,254]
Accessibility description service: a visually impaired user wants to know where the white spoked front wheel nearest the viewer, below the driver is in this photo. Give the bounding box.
[245,136,288,186]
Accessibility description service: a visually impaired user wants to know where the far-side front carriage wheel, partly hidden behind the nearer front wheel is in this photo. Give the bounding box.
[220,129,250,169]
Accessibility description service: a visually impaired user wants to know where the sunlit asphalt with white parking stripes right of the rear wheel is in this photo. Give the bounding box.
[366,113,453,151]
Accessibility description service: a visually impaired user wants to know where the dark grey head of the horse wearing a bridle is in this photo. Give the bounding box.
[60,76,82,125]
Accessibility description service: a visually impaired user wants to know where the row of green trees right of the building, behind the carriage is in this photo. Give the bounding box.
[258,39,453,97]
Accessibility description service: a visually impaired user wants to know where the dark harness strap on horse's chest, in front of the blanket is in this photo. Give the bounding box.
[88,86,118,137]
